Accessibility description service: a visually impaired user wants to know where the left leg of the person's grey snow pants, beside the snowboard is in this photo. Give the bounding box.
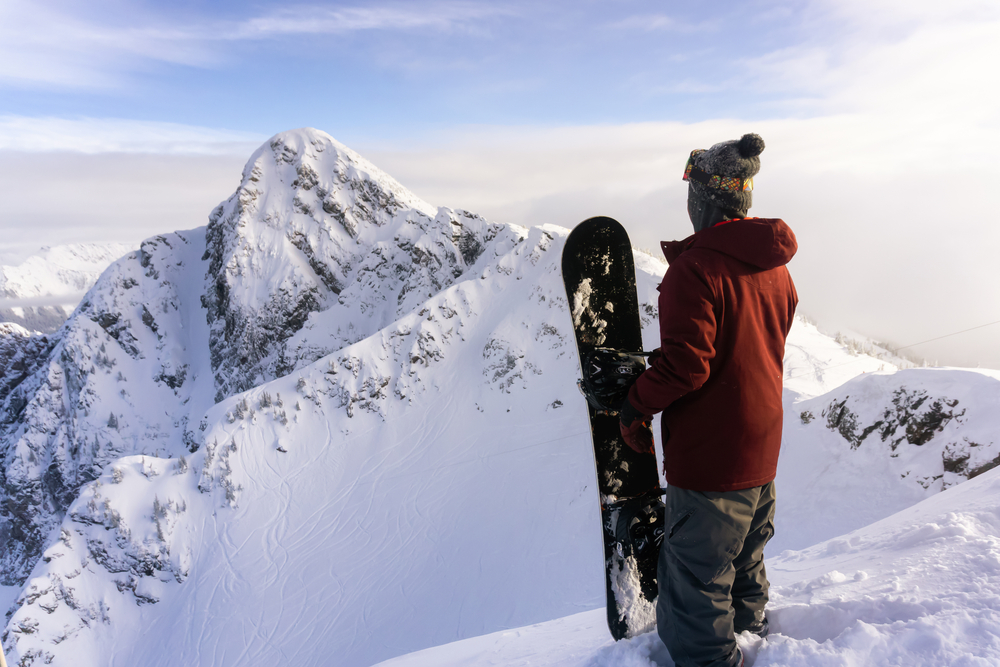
[656,487,773,667]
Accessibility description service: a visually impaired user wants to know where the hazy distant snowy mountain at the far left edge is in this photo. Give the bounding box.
[0,243,135,333]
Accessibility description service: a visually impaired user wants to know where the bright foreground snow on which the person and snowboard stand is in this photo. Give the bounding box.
[380,464,1000,667]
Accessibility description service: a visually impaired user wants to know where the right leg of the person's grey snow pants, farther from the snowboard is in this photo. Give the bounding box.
[733,482,775,630]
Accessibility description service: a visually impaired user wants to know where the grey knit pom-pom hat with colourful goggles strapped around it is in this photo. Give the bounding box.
[684,134,764,217]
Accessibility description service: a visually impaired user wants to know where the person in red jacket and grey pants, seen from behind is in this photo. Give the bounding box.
[620,134,798,667]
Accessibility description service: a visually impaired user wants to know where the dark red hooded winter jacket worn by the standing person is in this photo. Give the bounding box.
[629,218,798,491]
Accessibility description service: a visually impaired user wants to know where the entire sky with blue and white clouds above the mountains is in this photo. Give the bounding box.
[0,0,1000,368]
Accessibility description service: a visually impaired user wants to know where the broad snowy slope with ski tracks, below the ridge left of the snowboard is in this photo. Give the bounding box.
[5,220,603,665]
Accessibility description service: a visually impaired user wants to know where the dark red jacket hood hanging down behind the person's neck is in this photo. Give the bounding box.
[660,218,799,269]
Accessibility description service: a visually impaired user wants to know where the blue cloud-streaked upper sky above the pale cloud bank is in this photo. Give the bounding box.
[0,0,850,139]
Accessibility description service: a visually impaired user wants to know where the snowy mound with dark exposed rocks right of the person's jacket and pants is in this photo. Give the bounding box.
[767,368,1000,555]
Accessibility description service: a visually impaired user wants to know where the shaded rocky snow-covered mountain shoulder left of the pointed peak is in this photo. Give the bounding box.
[0,232,204,584]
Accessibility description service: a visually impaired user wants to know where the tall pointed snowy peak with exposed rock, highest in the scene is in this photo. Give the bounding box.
[203,129,501,400]
